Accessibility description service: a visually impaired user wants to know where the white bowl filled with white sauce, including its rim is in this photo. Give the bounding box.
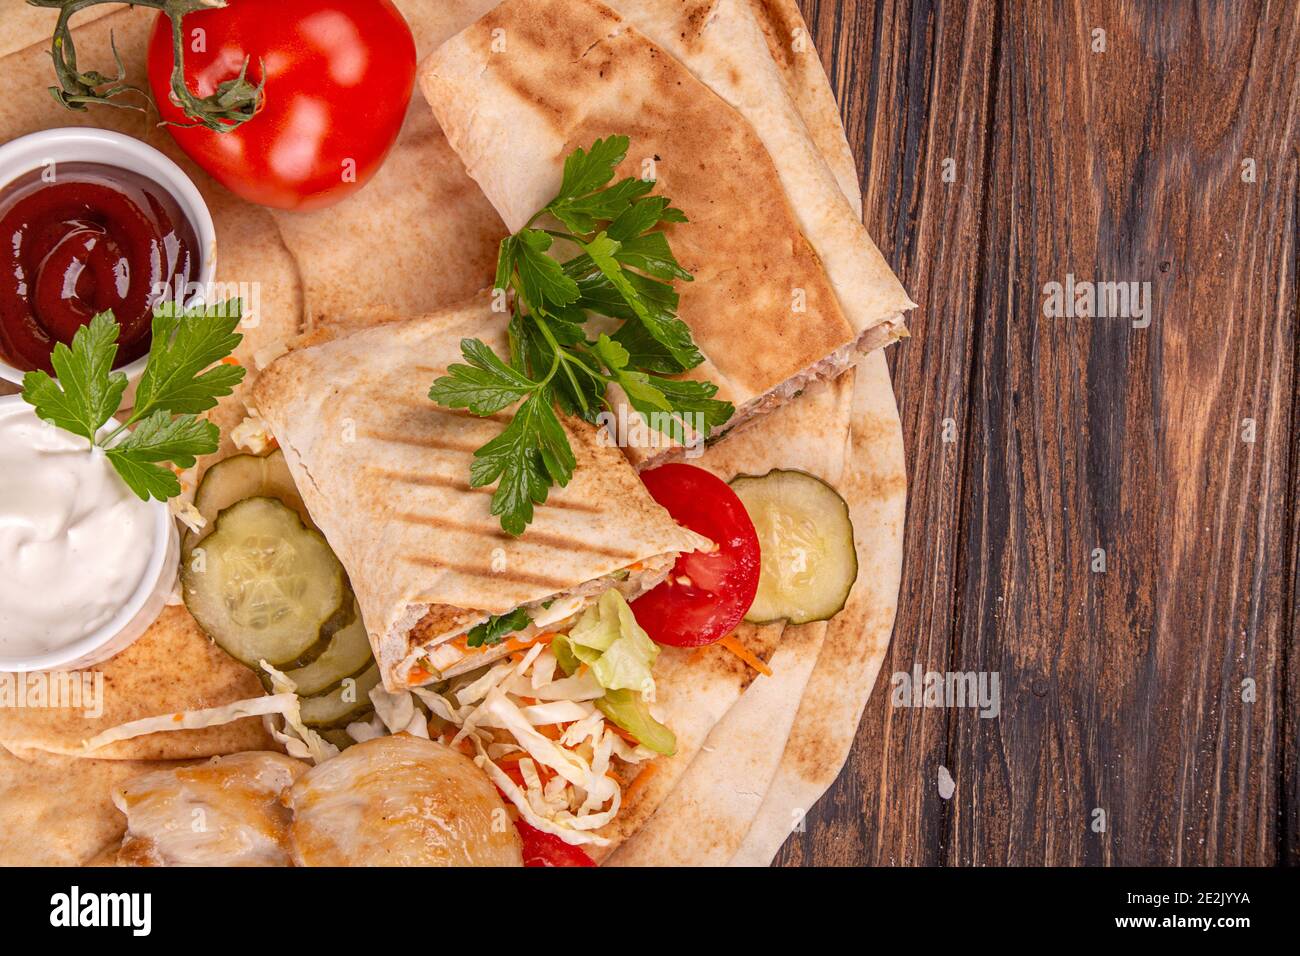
[0,395,179,671]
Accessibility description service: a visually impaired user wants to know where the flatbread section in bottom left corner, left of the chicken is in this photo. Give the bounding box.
[0,748,192,866]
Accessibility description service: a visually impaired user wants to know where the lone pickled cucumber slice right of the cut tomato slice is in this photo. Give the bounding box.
[731,468,858,624]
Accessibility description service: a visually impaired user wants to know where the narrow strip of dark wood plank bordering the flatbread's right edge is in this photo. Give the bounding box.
[779,1,995,865]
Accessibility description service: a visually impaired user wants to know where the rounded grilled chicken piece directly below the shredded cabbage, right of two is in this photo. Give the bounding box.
[287,734,524,866]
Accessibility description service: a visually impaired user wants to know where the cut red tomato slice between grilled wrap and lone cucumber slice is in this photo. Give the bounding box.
[632,463,762,648]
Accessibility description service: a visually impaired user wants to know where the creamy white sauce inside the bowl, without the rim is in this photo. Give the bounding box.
[0,402,155,658]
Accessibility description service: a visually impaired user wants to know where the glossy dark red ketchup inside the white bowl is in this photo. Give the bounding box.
[0,163,199,372]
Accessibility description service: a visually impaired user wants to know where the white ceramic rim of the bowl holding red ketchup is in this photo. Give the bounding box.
[0,126,217,388]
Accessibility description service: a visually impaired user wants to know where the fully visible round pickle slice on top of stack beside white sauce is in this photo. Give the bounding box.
[181,498,354,670]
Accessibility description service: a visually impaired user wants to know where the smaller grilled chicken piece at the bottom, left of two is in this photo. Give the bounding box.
[113,752,307,866]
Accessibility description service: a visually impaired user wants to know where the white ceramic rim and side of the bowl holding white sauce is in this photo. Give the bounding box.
[0,395,181,671]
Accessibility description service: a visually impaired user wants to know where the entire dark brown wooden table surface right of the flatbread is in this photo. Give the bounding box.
[779,0,1300,865]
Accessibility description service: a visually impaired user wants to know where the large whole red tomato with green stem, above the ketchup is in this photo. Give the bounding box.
[148,0,415,209]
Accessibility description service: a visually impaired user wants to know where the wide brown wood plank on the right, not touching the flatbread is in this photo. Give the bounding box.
[945,0,1300,865]
